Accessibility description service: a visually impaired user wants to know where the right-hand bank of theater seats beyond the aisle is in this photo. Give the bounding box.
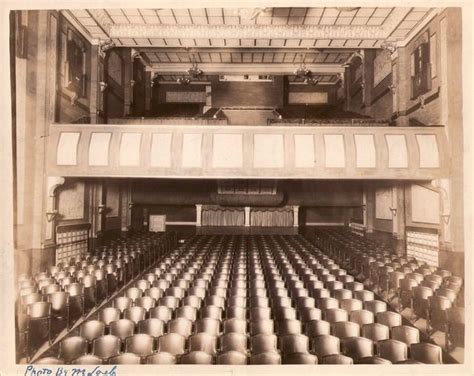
[314,229,465,350]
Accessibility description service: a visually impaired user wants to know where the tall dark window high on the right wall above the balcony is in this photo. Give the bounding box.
[410,42,431,99]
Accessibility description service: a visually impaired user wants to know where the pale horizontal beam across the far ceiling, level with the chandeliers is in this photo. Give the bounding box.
[146,63,345,75]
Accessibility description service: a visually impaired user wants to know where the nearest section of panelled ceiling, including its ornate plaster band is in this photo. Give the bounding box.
[66,7,433,49]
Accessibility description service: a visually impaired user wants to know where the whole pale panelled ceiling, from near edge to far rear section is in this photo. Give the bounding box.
[62,7,436,81]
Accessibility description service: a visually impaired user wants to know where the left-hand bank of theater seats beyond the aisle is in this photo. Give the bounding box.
[15,234,176,359]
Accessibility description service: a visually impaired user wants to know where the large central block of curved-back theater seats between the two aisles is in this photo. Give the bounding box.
[32,236,448,364]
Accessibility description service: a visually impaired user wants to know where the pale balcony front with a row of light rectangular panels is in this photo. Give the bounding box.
[48,124,450,180]
